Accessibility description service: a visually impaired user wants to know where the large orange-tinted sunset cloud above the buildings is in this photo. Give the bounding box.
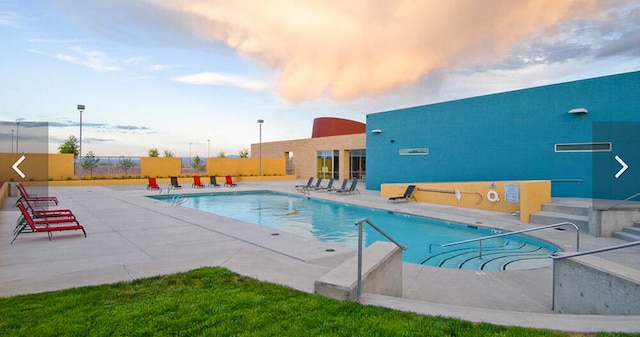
[142,0,628,102]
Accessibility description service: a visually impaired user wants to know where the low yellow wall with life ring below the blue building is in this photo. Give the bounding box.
[380,180,551,222]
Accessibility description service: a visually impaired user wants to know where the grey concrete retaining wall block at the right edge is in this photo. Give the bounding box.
[553,256,640,315]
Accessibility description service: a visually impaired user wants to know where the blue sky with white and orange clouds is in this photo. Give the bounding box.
[0,0,640,157]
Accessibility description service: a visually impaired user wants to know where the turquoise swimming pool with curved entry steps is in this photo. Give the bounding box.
[153,191,560,270]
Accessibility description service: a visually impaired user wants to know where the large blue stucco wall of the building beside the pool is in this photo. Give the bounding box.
[367,72,640,199]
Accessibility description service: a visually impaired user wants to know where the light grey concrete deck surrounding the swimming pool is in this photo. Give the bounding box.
[0,181,640,332]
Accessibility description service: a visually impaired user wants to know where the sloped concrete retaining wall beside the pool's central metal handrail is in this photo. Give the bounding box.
[314,241,402,300]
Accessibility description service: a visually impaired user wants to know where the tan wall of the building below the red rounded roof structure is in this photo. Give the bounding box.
[251,133,366,179]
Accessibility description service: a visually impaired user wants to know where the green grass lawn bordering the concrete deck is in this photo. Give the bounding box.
[0,268,623,336]
